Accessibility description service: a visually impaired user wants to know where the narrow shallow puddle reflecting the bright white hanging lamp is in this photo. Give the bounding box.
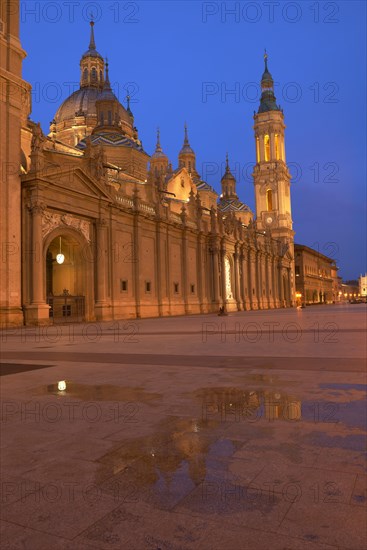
[32,380,162,405]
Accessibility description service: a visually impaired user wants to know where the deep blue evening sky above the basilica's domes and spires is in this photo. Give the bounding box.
[21,0,366,279]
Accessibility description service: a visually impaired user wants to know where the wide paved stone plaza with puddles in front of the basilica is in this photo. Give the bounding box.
[0,304,367,550]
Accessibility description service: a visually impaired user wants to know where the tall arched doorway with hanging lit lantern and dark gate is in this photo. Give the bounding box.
[45,230,90,323]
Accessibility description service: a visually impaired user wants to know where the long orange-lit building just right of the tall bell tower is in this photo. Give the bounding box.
[294,244,340,304]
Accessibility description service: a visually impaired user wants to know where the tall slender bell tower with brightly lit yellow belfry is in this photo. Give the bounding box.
[253,51,294,242]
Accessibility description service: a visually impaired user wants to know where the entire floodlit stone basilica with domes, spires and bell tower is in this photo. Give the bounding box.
[0,0,295,326]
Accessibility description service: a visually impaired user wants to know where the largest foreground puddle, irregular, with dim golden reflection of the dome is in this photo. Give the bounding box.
[96,417,224,508]
